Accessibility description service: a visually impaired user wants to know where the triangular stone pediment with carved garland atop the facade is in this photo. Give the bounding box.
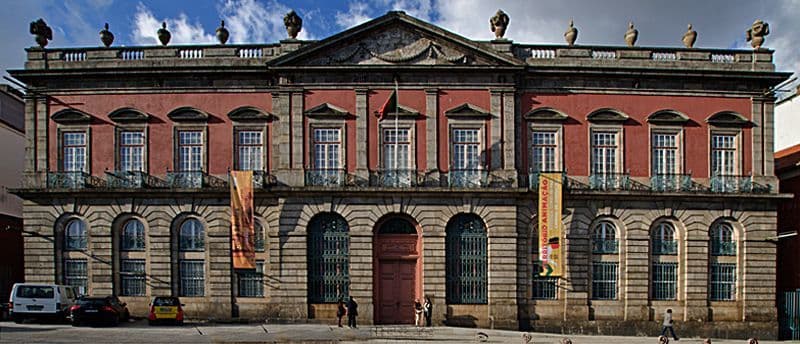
[270,11,524,67]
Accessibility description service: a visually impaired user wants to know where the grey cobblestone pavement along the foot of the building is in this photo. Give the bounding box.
[0,321,779,344]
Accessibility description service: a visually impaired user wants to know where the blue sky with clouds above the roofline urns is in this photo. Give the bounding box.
[0,0,800,87]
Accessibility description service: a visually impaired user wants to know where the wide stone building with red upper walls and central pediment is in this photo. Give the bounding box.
[9,12,788,339]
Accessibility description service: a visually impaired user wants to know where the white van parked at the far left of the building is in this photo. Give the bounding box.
[8,283,78,323]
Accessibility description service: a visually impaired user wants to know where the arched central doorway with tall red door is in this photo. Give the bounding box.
[373,216,422,324]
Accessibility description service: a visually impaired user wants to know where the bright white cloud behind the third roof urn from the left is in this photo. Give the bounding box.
[132,3,216,45]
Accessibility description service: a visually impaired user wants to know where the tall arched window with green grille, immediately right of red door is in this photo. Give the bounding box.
[445,214,488,304]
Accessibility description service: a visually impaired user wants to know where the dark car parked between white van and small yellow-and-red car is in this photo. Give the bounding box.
[69,296,130,326]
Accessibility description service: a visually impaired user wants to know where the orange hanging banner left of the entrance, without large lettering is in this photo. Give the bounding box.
[230,171,256,269]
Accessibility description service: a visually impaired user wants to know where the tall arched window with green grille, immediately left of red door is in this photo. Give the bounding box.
[307,213,350,303]
